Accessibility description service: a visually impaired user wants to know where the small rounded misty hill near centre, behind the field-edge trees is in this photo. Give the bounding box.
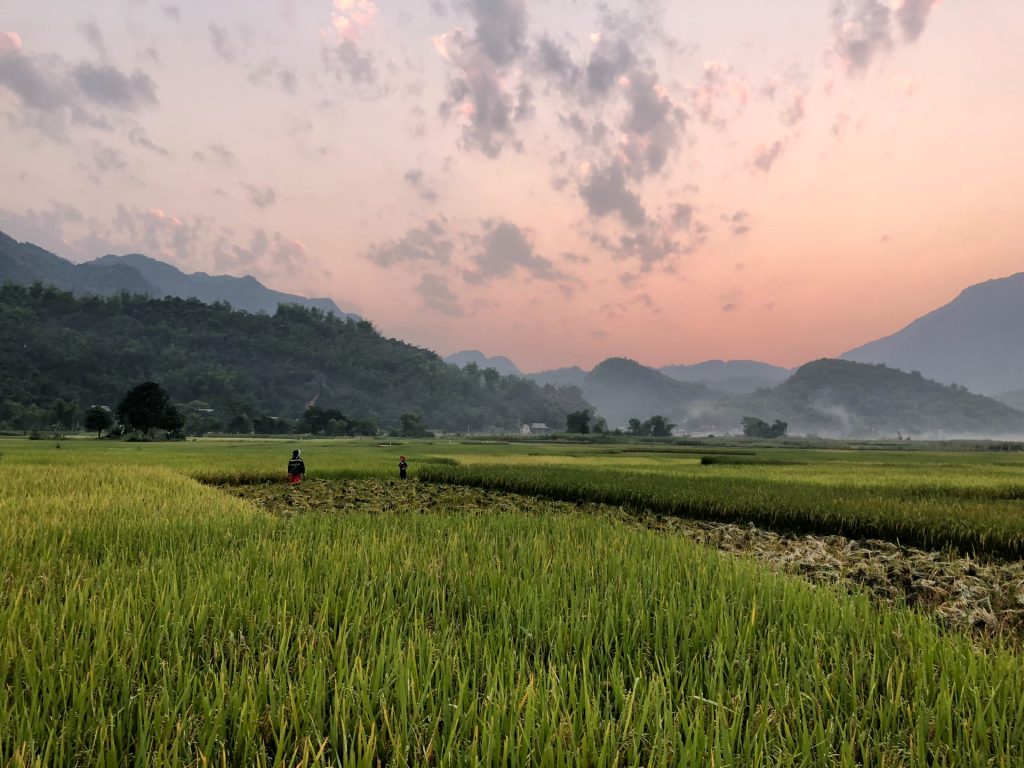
[583,357,715,428]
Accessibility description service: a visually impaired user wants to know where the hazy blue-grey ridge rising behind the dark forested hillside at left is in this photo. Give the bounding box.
[0,232,359,319]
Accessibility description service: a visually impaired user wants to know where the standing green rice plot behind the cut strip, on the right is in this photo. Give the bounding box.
[421,451,1024,557]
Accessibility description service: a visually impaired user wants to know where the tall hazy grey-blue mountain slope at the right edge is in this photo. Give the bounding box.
[843,272,1024,395]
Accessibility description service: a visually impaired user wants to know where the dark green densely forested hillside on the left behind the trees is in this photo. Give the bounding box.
[0,285,588,430]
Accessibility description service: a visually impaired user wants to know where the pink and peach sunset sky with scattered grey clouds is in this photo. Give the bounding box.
[0,0,1024,371]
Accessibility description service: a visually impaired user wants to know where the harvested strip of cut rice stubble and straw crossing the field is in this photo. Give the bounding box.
[225,479,1024,647]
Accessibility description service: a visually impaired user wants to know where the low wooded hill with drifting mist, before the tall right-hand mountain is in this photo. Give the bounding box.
[745,359,1024,437]
